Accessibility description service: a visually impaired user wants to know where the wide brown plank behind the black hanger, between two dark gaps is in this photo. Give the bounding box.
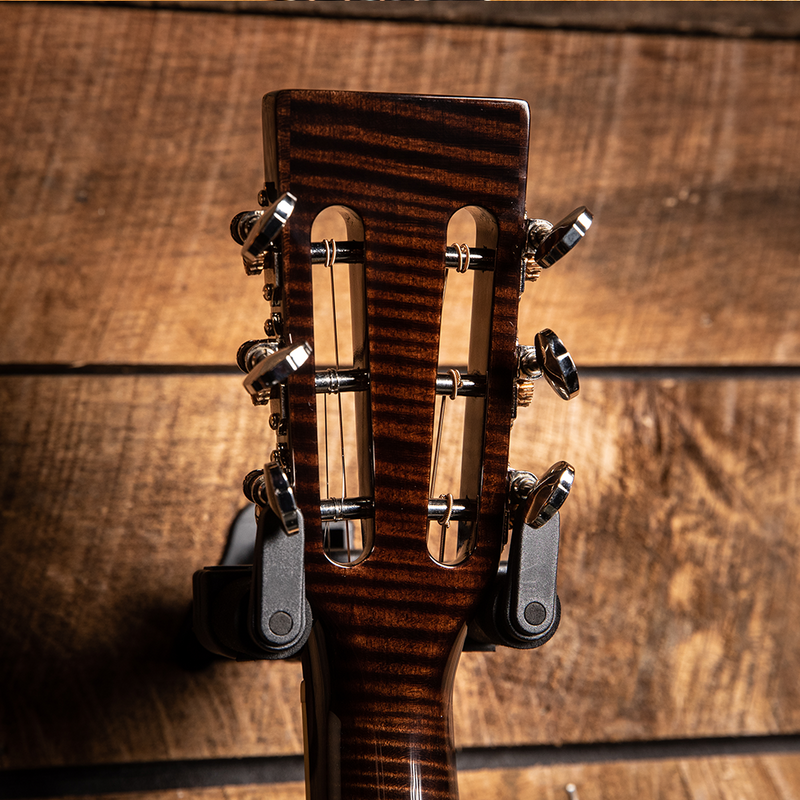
[0,376,800,768]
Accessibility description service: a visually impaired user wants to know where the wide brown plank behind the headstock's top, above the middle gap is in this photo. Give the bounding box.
[0,4,800,365]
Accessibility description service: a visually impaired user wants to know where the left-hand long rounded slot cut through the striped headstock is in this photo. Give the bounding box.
[310,206,374,566]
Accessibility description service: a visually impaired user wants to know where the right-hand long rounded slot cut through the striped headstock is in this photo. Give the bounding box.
[428,206,497,565]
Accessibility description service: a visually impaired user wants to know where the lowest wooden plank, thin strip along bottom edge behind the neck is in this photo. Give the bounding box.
[25,755,800,800]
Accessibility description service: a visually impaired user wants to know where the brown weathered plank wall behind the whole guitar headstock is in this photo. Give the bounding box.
[0,3,800,800]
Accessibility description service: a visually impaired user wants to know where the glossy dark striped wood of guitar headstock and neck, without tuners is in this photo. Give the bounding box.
[264,90,528,800]
